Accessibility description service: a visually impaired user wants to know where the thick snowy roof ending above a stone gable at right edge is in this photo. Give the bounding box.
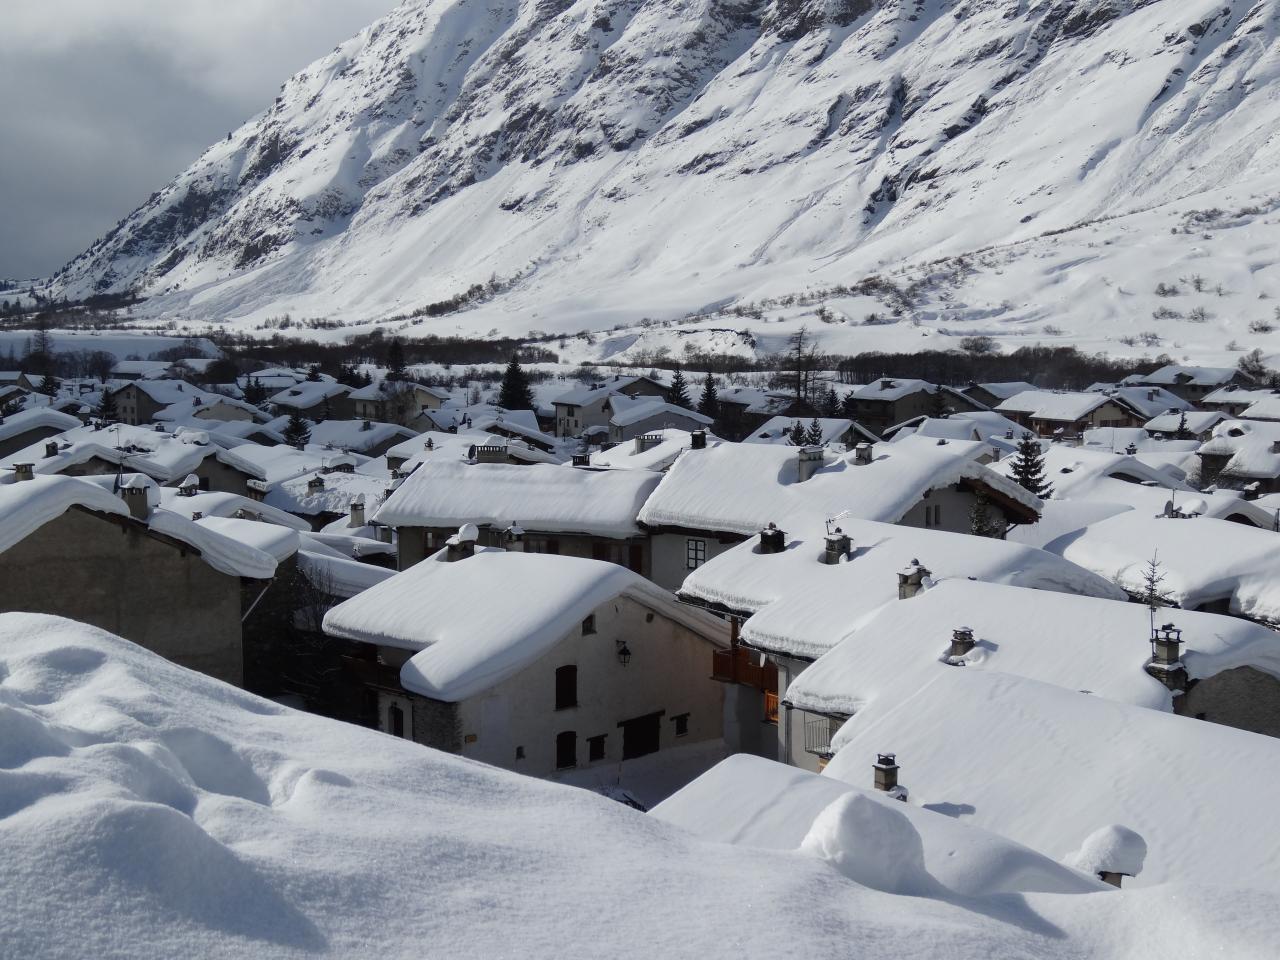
[786,580,1280,717]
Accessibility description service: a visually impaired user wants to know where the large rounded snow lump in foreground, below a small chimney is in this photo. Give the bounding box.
[800,794,941,896]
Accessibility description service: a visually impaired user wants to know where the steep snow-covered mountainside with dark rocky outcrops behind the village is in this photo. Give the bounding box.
[55,0,1280,348]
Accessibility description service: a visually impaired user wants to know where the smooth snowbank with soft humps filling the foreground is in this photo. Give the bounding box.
[0,613,1280,960]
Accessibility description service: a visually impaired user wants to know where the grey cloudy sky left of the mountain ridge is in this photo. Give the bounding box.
[0,0,396,278]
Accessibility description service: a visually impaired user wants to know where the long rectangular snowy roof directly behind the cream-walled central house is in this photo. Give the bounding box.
[374,460,659,538]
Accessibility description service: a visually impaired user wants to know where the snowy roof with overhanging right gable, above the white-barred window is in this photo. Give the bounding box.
[640,438,1039,535]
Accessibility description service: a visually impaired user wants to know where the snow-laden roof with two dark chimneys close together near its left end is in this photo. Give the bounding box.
[680,520,1124,659]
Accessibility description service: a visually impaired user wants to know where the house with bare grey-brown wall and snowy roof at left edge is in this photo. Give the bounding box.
[0,471,275,686]
